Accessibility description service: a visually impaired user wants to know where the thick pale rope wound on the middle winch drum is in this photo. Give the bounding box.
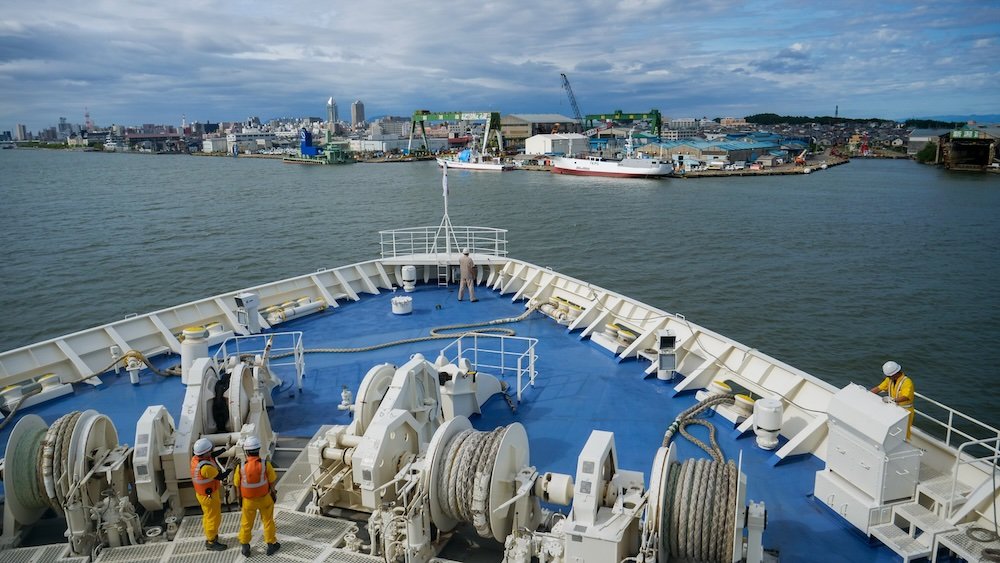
[438,426,507,538]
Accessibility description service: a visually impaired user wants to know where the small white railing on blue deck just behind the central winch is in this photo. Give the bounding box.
[441,332,538,403]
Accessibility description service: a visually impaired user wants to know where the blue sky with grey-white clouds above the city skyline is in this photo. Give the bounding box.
[0,0,1000,131]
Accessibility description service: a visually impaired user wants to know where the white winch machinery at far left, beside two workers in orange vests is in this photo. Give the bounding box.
[0,342,278,557]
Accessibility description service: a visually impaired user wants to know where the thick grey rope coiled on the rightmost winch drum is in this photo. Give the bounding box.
[660,394,739,562]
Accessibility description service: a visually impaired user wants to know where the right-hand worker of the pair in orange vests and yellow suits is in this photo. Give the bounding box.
[233,436,281,557]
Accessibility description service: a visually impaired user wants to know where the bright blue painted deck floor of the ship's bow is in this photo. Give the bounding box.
[0,286,899,562]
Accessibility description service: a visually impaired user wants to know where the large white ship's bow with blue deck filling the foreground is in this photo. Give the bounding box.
[0,168,1000,563]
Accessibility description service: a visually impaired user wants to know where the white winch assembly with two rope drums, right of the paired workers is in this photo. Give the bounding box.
[300,360,764,563]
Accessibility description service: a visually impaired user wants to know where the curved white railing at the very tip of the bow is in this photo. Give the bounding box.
[379,224,507,258]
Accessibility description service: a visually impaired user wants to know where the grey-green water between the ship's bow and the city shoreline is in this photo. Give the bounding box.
[0,149,1000,426]
